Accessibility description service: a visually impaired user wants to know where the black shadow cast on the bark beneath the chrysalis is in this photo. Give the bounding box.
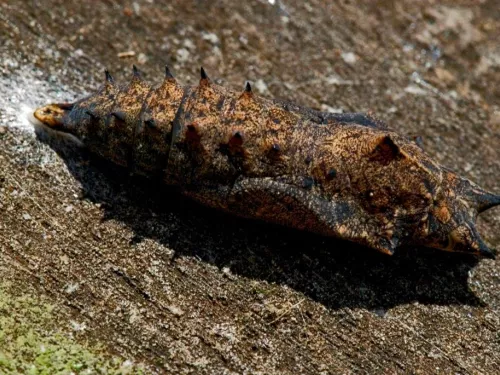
[37,121,483,315]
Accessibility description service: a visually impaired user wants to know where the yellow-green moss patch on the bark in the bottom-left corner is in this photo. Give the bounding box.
[0,284,145,375]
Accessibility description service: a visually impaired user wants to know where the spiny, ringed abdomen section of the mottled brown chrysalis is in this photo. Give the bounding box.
[69,70,356,197]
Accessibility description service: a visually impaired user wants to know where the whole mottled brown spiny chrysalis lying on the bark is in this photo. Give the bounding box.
[34,66,500,258]
